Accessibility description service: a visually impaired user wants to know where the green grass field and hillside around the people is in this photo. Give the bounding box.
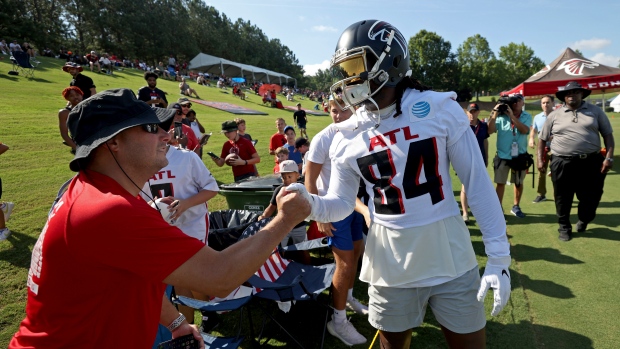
[0,56,620,349]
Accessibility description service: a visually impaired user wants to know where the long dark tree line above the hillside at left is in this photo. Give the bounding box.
[0,0,303,78]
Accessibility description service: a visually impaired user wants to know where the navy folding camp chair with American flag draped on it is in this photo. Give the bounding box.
[239,218,336,348]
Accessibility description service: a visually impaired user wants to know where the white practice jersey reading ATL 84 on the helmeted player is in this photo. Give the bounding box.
[310,89,509,256]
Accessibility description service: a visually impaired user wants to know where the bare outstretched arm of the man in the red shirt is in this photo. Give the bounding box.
[164,188,310,297]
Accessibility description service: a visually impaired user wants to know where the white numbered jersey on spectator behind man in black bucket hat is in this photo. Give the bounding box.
[140,146,219,243]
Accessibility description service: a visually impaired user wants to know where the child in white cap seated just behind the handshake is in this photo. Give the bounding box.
[258,160,311,264]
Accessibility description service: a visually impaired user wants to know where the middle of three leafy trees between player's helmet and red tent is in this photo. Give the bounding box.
[457,34,496,101]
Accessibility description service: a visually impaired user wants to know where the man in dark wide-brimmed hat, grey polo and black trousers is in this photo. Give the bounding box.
[537,81,614,241]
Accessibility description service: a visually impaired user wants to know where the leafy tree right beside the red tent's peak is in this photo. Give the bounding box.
[492,42,545,90]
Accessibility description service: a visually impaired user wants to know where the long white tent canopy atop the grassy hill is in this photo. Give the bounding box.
[189,53,297,85]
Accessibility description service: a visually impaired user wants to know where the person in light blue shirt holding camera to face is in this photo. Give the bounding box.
[489,95,532,218]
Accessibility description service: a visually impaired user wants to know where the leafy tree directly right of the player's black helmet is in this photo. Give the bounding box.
[409,29,460,91]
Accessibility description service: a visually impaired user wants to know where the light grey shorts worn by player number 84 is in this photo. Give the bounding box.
[368,268,486,334]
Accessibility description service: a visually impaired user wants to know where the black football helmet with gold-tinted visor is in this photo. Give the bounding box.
[330,20,411,109]
